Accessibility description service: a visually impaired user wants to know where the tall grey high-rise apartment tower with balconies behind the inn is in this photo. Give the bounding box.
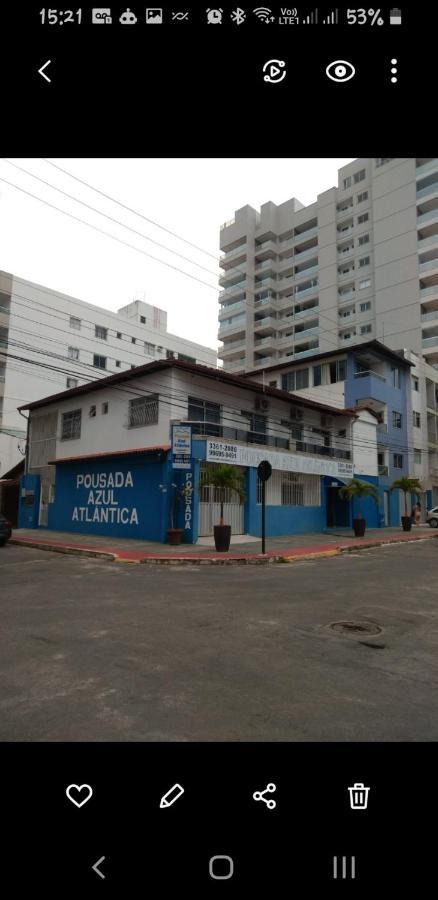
[218,158,438,374]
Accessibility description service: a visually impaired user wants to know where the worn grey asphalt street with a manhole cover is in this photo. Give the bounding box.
[0,541,438,741]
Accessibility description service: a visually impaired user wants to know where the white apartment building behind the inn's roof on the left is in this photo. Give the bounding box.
[0,271,217,477]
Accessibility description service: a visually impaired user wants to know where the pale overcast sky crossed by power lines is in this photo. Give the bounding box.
[0,157,353,349]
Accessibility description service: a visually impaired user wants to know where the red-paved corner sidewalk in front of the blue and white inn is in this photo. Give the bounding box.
[11,526,438,565]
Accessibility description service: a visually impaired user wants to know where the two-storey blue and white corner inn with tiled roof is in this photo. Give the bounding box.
[19,356,396,542]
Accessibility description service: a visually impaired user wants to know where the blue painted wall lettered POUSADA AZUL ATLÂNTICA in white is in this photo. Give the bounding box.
[48,454,169,541]
